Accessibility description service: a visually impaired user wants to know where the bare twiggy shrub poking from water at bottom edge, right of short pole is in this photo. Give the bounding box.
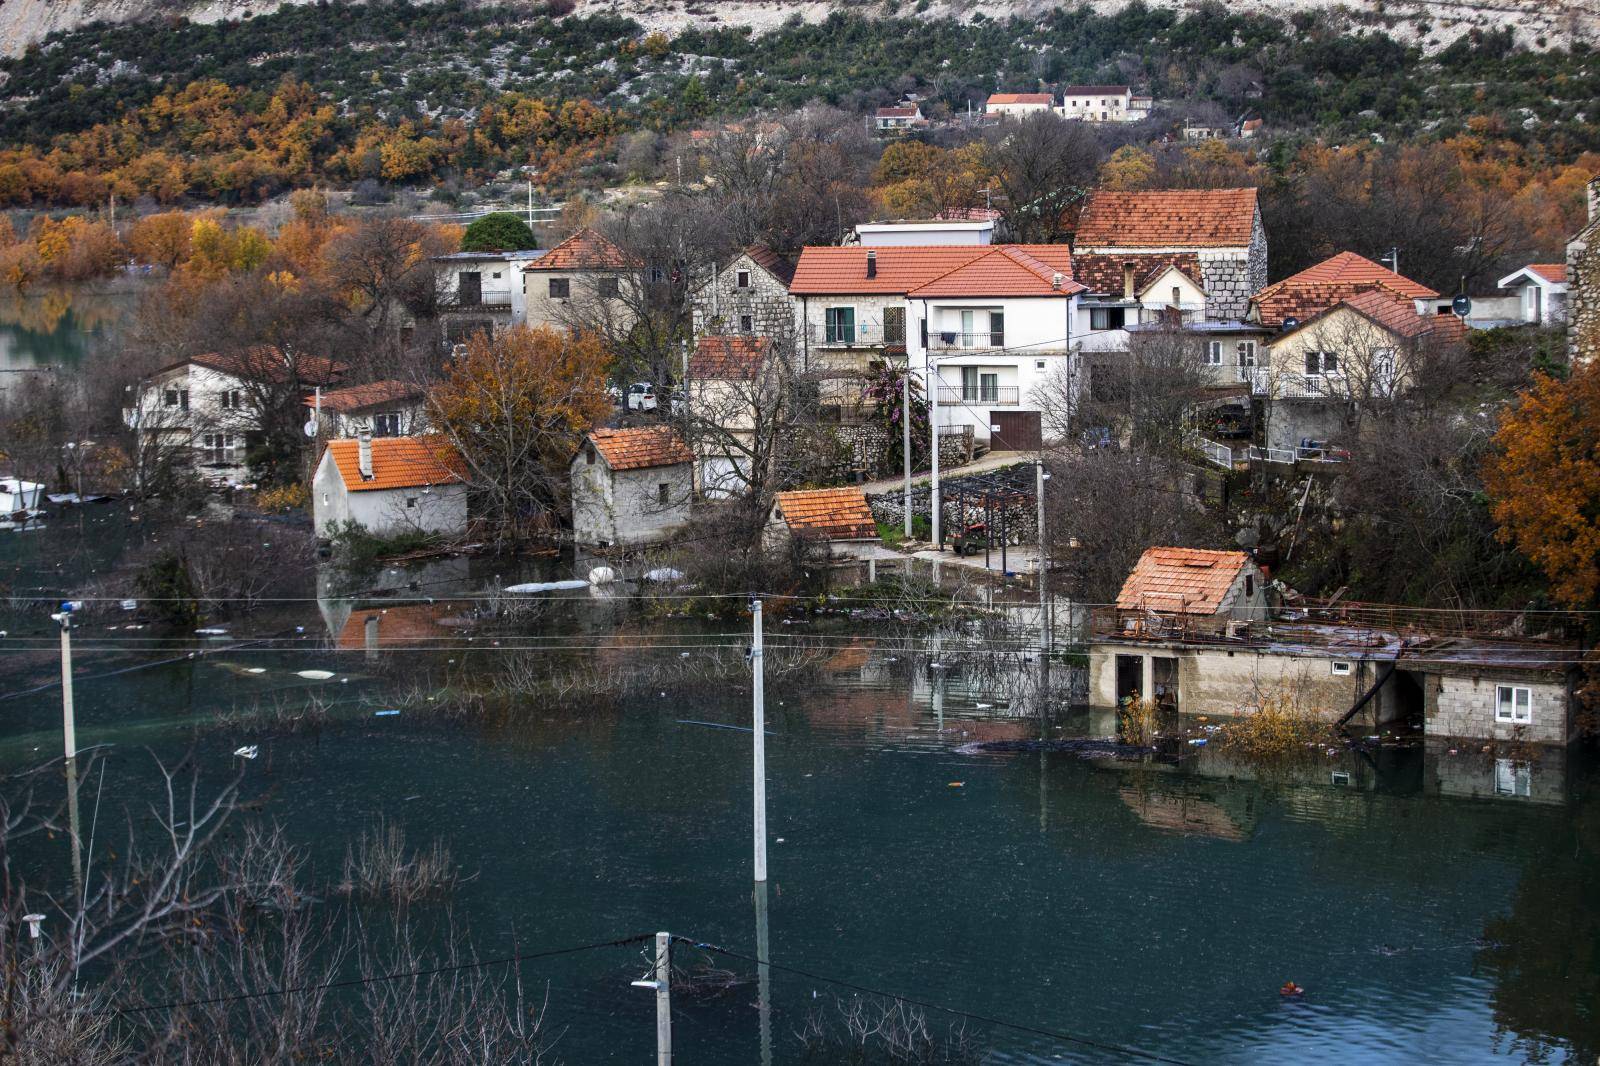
[795,996,982,1066]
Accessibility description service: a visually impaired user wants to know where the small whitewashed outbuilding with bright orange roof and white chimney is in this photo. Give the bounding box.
[312,434,467,536]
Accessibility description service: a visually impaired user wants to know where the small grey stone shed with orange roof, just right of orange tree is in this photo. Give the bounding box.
[571,426,694,547]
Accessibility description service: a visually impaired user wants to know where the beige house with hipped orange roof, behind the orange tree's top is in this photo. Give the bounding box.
[522,229,645,333]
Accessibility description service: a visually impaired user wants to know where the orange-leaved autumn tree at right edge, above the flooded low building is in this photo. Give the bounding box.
[1483,365,1600,608]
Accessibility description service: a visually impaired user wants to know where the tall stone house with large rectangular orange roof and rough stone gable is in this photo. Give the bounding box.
[1072,189,1267,320]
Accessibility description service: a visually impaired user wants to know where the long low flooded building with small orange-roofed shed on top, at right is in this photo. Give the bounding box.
[1090,547,1579,746]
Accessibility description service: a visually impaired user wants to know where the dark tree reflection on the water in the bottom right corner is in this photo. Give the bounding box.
[1478,776,1600,1063]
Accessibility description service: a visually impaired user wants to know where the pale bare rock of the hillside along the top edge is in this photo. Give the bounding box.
[0,0,1600,54]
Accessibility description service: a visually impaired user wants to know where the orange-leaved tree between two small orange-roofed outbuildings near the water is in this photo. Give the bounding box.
[429,327,611,544]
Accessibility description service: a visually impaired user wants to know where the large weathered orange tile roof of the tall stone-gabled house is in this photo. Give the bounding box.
[1074,189,1256,251]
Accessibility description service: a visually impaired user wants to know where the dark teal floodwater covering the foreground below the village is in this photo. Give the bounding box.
[0,519,1600,1064]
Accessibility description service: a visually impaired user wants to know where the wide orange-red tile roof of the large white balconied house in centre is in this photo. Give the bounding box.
[789,245,1078,296]
